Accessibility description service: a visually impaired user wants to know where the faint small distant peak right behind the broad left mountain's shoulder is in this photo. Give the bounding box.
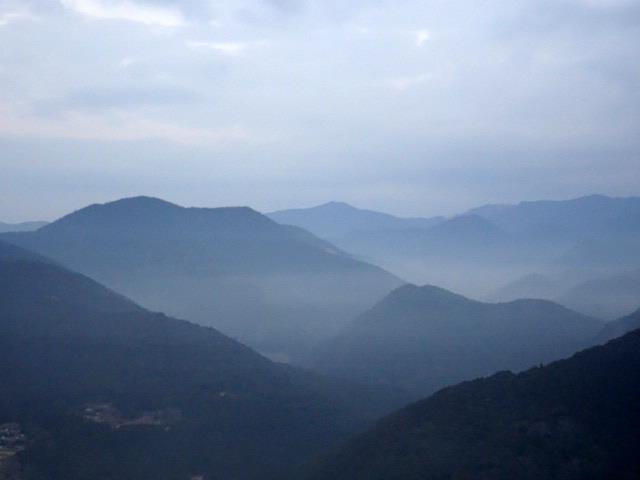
[267,202,442,241]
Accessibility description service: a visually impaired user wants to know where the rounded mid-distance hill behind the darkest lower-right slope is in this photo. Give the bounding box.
[316,285,602,396]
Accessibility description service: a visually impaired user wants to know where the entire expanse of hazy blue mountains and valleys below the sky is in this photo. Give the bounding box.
[0,196,640,480]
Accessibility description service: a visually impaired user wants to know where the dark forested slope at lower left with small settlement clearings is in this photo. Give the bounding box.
[0,242,404,480]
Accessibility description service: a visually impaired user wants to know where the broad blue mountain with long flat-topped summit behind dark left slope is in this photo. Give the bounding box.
[3,197,402,356]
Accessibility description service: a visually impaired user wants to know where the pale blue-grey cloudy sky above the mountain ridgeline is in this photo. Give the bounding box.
[0,0,640,222]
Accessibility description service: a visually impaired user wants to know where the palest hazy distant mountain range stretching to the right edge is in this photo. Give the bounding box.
[271,195,640,298]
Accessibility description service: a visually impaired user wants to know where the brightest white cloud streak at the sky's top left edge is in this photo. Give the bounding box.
[60,0,185,27]
